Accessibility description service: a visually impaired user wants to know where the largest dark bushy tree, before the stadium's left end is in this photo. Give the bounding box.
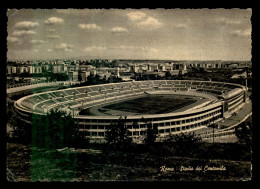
[32,110,88,149]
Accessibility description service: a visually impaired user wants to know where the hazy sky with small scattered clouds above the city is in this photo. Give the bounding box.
[7,9,252,61]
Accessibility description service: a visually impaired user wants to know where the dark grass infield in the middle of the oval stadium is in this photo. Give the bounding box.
[100,95,197,114]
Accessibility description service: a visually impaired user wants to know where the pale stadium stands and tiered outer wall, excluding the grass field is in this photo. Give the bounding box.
[15,80,247,142]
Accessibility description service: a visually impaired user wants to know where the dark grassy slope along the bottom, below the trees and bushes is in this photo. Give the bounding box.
[7,144,251,181]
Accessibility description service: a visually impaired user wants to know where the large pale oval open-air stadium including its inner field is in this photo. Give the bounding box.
[14,80,247,142]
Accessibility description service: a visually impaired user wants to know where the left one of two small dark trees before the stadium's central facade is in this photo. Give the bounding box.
[105,117,132,148]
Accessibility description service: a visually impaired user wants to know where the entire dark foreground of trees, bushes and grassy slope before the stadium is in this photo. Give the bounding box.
[6,106,252,182]
